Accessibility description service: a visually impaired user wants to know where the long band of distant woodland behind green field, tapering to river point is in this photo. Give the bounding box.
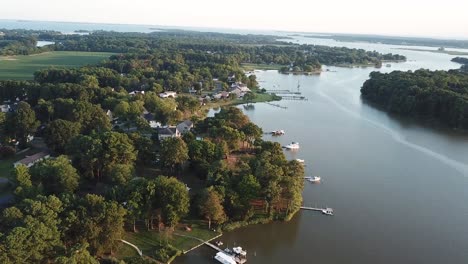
[0,30,406,70]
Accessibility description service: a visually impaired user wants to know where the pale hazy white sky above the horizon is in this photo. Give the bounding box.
[0,0,468,39]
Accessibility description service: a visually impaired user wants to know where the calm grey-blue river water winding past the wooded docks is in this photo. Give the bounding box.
[176,38,468,264]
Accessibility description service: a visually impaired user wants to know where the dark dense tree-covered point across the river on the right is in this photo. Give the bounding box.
[361,70,468,130]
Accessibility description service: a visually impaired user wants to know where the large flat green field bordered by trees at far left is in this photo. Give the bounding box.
[0,51,112,80]
